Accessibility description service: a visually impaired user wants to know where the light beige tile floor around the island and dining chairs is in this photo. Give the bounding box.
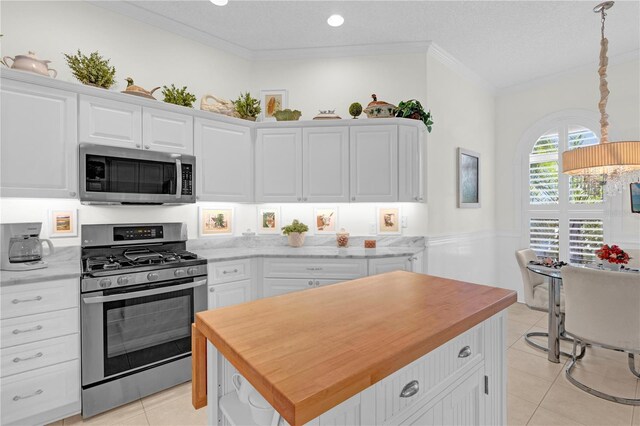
[51,304,640,426]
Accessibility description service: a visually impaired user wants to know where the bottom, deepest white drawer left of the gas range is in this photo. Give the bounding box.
[1,360,80,425]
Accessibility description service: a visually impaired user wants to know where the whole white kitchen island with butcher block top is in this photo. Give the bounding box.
[192,272,516,425]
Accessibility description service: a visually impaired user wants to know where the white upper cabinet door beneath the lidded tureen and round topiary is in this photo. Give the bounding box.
[349,125,398,202]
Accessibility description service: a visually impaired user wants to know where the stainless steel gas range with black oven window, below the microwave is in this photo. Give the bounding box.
[81,223,207,417]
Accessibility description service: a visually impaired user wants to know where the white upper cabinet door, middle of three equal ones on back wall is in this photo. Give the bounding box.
[302,127,349,203]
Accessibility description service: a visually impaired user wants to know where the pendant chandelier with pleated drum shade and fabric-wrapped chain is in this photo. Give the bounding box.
[562,1,640,196]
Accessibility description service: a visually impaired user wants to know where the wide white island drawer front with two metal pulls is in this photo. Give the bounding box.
[375,324,484,424]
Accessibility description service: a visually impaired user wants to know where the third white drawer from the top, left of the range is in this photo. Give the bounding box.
[0,334,80,377]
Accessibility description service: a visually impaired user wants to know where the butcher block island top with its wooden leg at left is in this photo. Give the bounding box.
[193,271,516,425]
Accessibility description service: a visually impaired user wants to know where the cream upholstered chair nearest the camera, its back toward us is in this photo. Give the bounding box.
[561,266,640,405]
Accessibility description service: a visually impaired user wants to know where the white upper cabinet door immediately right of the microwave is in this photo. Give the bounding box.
[194,118,253,202]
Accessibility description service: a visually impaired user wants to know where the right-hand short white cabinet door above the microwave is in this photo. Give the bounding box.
[142,108,193,155]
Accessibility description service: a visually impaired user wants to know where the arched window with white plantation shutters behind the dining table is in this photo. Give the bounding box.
[525,122,605,263]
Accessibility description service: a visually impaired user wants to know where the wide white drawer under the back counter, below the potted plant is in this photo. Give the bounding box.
[263,257,367,280]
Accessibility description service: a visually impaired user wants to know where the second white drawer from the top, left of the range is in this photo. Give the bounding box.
[0,308,80,348]
